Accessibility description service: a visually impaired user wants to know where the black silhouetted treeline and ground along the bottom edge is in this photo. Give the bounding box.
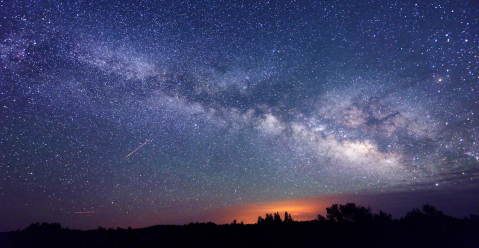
[0,203,479,247]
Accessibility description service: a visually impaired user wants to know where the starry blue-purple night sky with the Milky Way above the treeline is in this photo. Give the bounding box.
[0,0,479,231]
